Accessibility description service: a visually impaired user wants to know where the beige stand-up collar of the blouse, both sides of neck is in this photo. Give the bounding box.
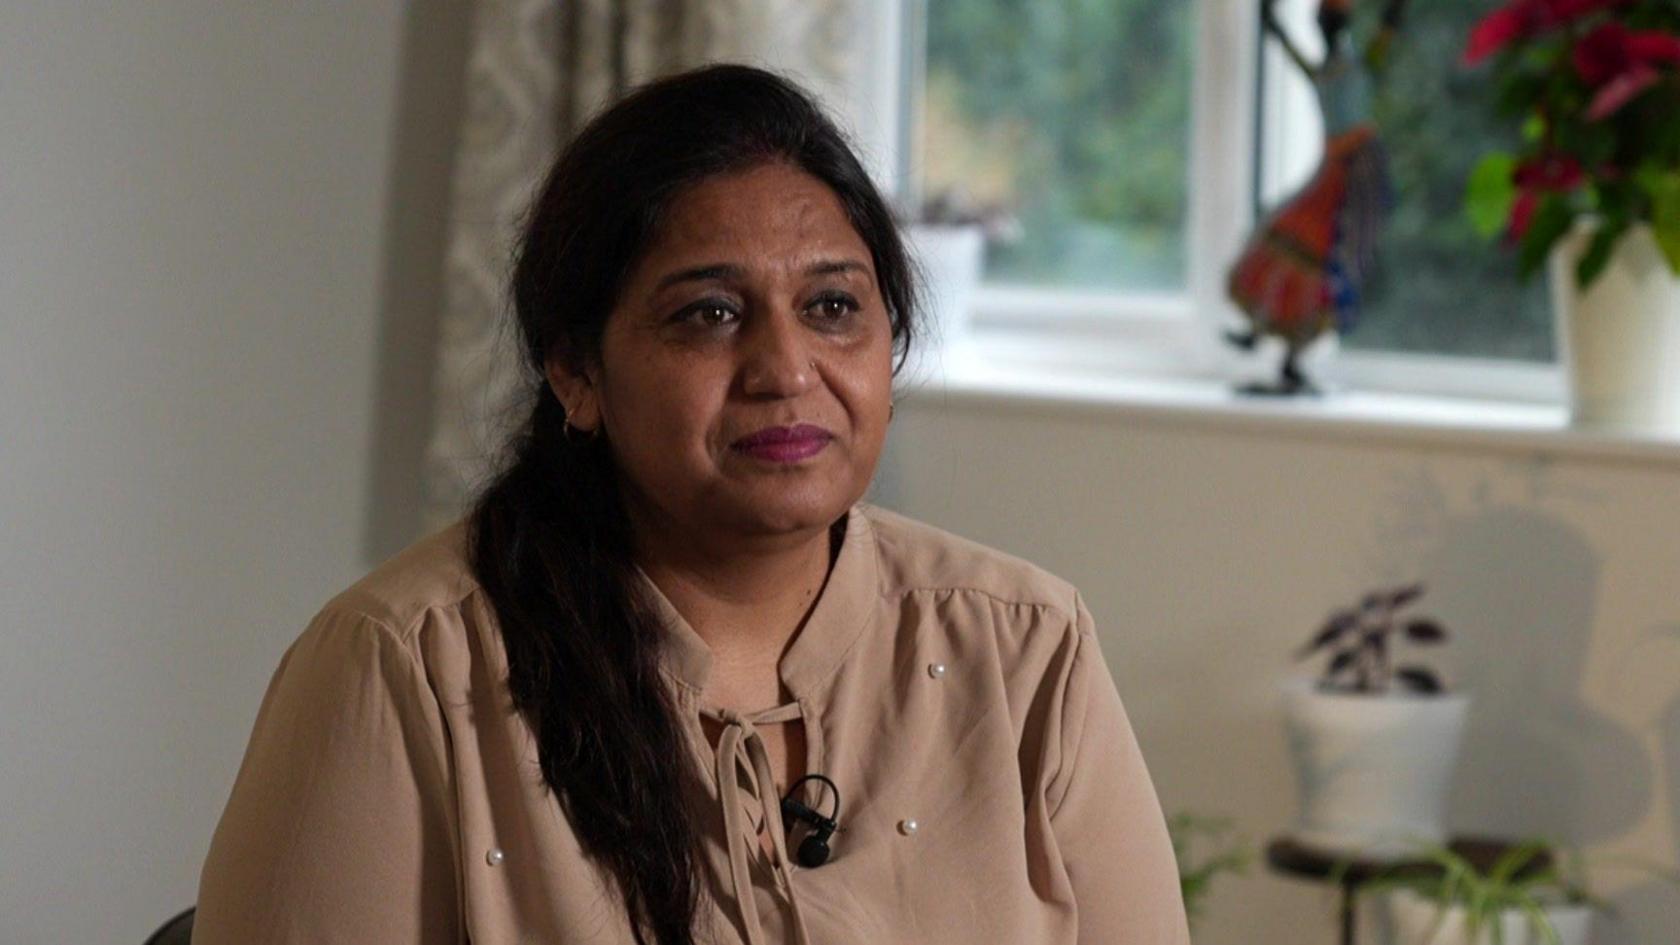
[637,504,879,700]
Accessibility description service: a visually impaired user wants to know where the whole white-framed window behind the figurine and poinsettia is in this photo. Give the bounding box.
[900,0,1561,400]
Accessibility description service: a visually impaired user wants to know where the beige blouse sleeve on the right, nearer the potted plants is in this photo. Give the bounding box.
[1047,597,1189,945]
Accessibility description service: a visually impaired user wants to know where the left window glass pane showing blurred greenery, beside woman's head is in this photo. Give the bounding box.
[912,0,1193,291]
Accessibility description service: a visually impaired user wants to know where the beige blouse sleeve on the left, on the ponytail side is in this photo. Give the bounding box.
[193,605,460,945]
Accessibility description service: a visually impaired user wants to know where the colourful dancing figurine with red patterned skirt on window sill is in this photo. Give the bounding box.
[1226,0,1404,395]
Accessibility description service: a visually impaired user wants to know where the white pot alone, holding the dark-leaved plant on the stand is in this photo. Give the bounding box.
[1284,679,1470,858]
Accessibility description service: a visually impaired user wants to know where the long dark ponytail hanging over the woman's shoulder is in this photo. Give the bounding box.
[472,388,697,945]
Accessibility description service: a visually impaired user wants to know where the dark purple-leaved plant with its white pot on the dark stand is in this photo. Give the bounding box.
[1284,583,1470,858]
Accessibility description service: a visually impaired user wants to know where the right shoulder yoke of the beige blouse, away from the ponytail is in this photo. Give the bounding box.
[860,506,1080,622]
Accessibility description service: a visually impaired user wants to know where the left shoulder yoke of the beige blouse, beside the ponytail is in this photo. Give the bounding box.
[318,518,479,646]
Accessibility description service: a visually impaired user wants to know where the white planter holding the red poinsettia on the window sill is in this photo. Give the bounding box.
[1551,222,1680,430]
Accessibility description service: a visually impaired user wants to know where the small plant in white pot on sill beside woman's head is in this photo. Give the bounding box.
[904,188,1015,351]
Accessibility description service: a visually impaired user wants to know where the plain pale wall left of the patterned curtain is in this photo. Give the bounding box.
[0,7,440,943]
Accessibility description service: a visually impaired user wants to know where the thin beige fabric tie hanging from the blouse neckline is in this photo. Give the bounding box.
[701,703,811,945]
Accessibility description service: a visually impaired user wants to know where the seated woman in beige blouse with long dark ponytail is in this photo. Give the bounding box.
[195,66,1186,945]
